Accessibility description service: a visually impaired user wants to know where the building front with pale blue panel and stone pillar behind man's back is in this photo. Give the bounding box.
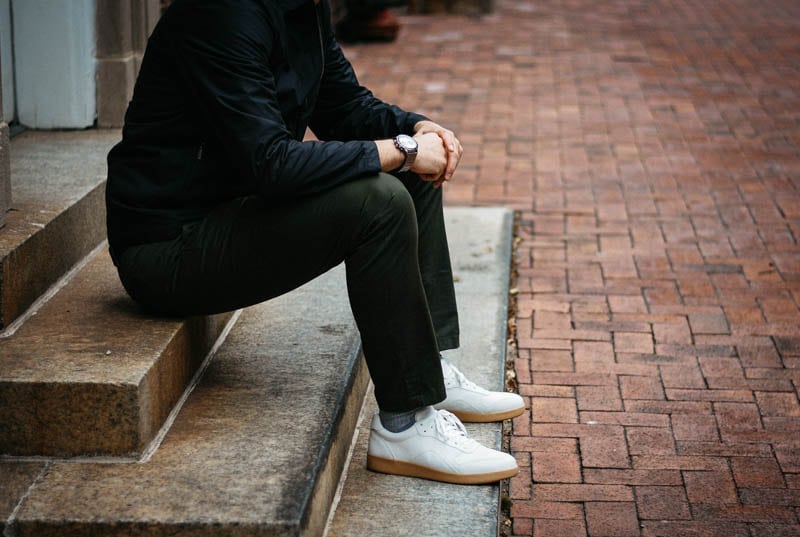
[0,0,161,224]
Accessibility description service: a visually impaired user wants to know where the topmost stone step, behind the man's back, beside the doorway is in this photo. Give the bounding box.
[0,130,120,328]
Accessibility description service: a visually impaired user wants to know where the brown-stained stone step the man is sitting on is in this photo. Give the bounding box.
[0,252,230,456]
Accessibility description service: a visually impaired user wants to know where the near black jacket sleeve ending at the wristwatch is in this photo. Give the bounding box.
[168,2,380,198]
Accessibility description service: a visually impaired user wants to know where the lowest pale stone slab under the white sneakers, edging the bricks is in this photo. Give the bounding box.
[328,208,512,537]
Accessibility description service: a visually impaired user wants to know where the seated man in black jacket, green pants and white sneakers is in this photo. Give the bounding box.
[107,0,524,483]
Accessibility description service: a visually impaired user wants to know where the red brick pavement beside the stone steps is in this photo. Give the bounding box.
[347,0,800,537]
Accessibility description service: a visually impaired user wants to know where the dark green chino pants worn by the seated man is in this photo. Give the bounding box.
[117,173,459,411]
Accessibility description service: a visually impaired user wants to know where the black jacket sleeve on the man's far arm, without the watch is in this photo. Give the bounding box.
[311,10,427,140]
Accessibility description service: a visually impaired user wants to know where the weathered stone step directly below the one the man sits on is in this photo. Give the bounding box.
[15,264,368,537]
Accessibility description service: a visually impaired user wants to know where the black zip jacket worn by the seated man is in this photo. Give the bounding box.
[106,0,424,255]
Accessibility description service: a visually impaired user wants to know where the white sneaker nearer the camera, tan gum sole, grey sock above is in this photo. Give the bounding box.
[367,407,518,485]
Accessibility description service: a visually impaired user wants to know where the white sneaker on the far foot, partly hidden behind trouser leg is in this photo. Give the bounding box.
[434,359,525,422]
